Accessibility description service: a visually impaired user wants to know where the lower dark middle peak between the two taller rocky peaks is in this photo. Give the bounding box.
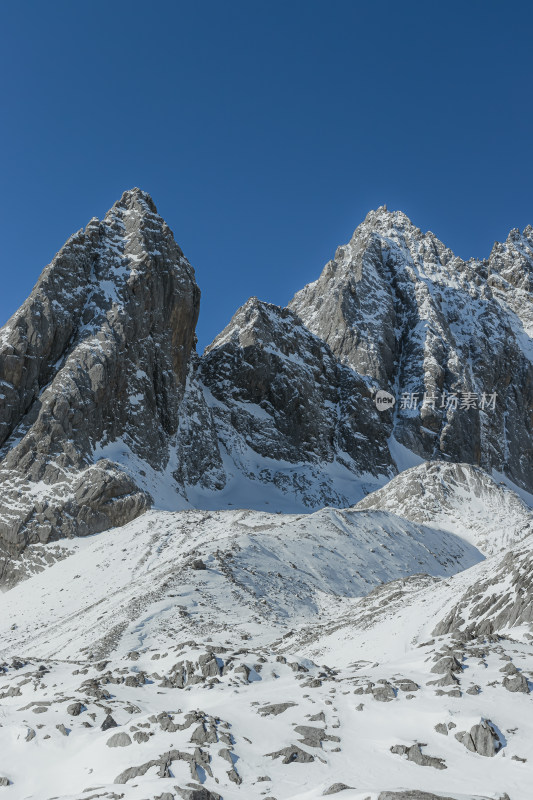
[195,298,393,507]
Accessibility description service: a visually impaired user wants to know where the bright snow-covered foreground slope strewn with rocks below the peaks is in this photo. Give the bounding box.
[0,509,533,800]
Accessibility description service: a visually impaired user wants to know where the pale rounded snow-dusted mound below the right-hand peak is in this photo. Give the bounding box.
[356,461,533,555]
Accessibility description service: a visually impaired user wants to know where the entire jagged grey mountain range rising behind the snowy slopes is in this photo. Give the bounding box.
[0,189,533,584]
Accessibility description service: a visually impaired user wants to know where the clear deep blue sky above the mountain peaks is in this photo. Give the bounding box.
[0,0,533,350]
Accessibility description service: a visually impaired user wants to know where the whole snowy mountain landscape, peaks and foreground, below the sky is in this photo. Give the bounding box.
[0,189,533,800]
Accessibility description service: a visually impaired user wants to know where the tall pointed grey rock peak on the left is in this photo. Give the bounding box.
[0,189,199,572]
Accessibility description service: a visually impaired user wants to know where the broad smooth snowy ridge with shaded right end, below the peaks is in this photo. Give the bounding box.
[0,509,483,658]
